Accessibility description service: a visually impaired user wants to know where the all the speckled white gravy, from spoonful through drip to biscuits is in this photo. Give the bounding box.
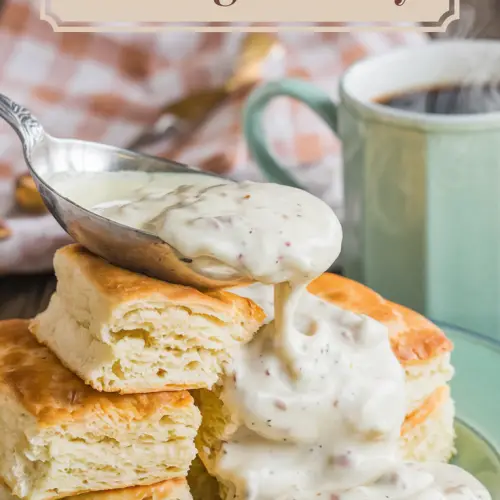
[52,170,491,500]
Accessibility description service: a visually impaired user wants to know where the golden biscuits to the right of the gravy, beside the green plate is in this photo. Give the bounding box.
[310,274,455,462]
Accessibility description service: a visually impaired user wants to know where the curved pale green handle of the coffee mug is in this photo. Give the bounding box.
[243,79,337,189]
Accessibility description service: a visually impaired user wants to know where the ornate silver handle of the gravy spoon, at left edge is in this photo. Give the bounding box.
[0,94,45,159]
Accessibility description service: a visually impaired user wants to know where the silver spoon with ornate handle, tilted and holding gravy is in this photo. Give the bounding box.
[0,94,244,289]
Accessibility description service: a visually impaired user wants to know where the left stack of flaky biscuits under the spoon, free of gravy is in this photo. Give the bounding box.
[0,245,264,500]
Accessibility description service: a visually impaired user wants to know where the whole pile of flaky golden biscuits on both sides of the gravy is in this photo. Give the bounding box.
[0,245,454,500]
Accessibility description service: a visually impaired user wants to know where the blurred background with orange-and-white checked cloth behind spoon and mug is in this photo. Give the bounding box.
[0,0,500,326]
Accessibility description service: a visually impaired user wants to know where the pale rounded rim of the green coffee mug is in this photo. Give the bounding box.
[339,40,500,131]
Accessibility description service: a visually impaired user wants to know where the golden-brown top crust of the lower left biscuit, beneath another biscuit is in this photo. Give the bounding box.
[0,320,194,426]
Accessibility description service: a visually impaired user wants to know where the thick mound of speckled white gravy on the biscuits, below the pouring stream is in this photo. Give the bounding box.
[217,293,405,500]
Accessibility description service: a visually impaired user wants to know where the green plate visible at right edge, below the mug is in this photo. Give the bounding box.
[440,323,500,500]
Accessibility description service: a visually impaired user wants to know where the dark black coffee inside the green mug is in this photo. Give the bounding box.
[376,83,500,115]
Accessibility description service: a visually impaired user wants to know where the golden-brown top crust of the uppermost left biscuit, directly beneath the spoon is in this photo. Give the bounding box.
[54,245,265,324]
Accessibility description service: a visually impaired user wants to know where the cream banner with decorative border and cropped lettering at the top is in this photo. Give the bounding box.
[41,0,459,31]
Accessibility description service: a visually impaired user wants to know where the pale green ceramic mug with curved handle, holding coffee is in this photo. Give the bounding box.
[244,41,500,338]
